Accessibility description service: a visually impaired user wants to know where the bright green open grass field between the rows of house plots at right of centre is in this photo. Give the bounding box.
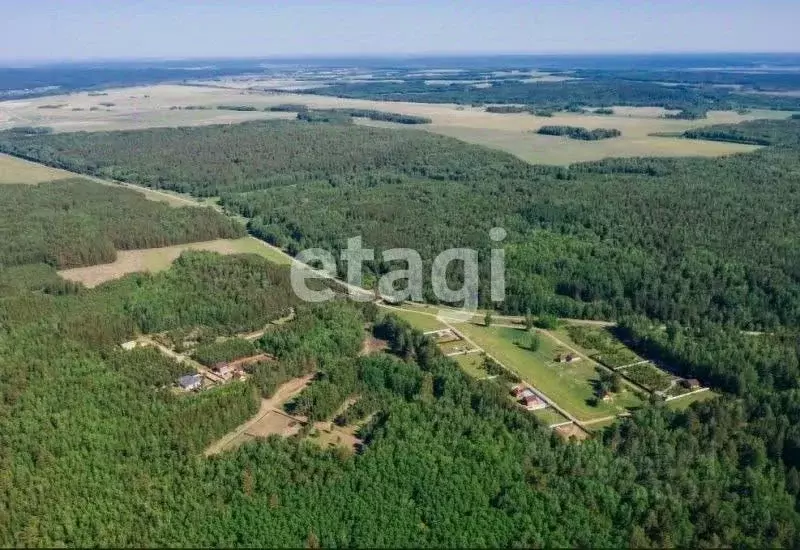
[458,324,641,420]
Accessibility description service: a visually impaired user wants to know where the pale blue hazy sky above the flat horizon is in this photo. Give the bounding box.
[0,0,800,61]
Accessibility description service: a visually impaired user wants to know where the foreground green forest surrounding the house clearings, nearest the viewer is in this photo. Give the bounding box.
[0,249,800,547]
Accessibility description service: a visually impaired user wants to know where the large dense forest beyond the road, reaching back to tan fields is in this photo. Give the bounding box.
[0,120,800,330]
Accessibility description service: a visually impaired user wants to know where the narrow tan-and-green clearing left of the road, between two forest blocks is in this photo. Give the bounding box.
[58,237,288,288]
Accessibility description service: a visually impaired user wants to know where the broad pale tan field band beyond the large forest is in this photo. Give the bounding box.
[0,82,788,164]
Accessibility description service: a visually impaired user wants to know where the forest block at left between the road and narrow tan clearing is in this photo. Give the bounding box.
[0,178,244,268]
